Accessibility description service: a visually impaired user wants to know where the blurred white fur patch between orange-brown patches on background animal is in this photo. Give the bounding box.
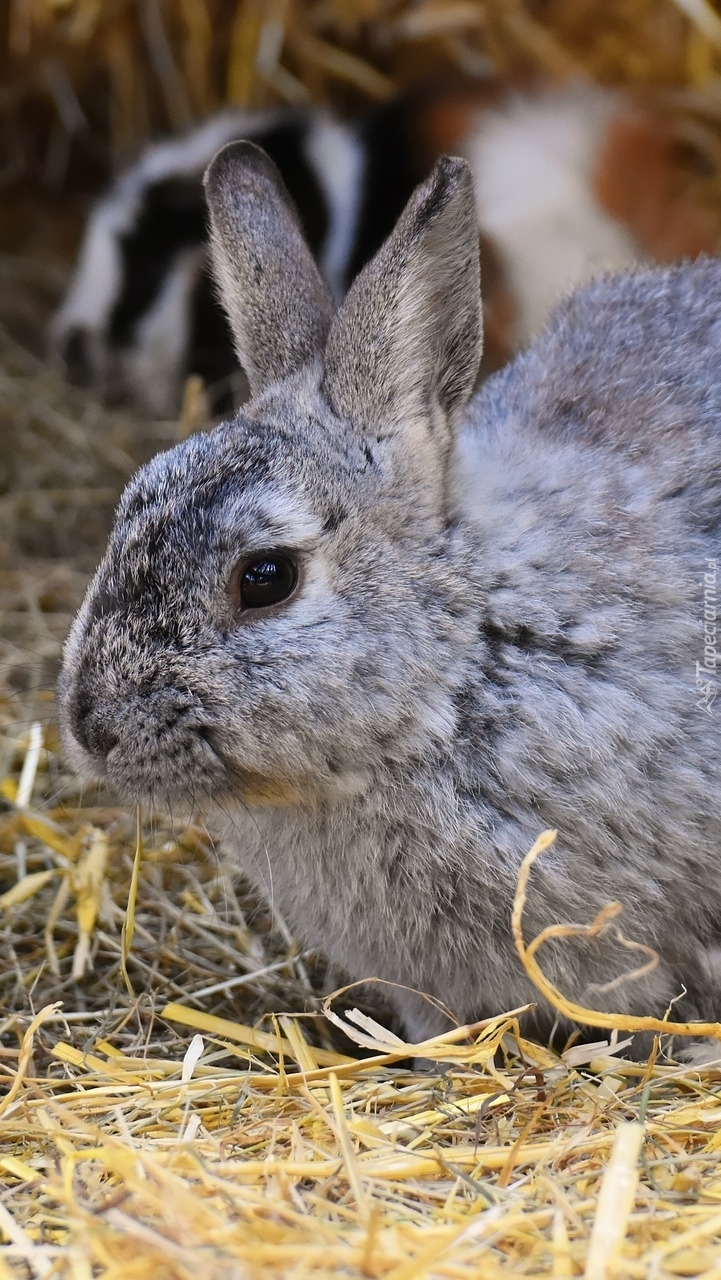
[464,87,640,344]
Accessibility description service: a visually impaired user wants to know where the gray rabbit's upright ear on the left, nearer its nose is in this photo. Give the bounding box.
[205,142,333,396]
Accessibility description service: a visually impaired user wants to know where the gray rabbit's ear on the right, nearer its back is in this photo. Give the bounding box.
[323,156,483,442]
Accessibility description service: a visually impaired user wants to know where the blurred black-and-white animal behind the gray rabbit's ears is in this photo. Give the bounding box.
[51,105,435,416]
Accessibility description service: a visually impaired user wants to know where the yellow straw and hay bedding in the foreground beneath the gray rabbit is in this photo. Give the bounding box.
[0,762,721,1280]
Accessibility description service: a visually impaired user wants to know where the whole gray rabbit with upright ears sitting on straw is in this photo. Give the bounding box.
[60,143,721,1042]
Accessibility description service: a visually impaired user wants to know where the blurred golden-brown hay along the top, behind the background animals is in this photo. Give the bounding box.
[7,0,721,257]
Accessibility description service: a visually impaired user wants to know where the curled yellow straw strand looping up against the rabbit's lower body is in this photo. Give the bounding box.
[511,831,721,1041]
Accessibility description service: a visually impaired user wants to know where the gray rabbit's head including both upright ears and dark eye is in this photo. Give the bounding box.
[60,143,480,804]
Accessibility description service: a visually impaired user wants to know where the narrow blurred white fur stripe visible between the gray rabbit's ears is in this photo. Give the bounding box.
[305,116,365,302]
